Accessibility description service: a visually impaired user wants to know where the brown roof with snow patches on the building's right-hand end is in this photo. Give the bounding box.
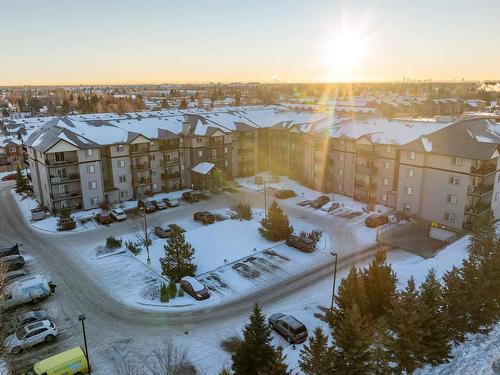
[402,118,500,160]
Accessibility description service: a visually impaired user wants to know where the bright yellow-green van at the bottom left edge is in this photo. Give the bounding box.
[30,347,89,375]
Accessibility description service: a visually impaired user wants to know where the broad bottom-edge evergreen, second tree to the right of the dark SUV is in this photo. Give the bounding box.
[332,304,372,375]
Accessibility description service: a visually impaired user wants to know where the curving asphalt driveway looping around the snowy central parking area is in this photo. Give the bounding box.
[0,183,382,375]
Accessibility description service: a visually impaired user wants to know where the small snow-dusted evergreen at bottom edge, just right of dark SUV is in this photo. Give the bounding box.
[299,327,334,375]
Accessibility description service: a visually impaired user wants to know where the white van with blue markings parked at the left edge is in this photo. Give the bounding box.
[0,274,55,311]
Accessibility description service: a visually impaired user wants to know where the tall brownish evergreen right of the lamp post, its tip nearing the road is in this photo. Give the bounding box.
[362,250,397,320]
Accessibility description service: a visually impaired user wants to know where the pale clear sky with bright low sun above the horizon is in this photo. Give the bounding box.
[0,0,500,85]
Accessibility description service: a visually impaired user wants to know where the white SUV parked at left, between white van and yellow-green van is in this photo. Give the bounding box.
[4,319,57,354]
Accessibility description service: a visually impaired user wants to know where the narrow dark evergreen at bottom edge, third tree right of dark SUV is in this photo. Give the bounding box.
[370,317,394,375]
